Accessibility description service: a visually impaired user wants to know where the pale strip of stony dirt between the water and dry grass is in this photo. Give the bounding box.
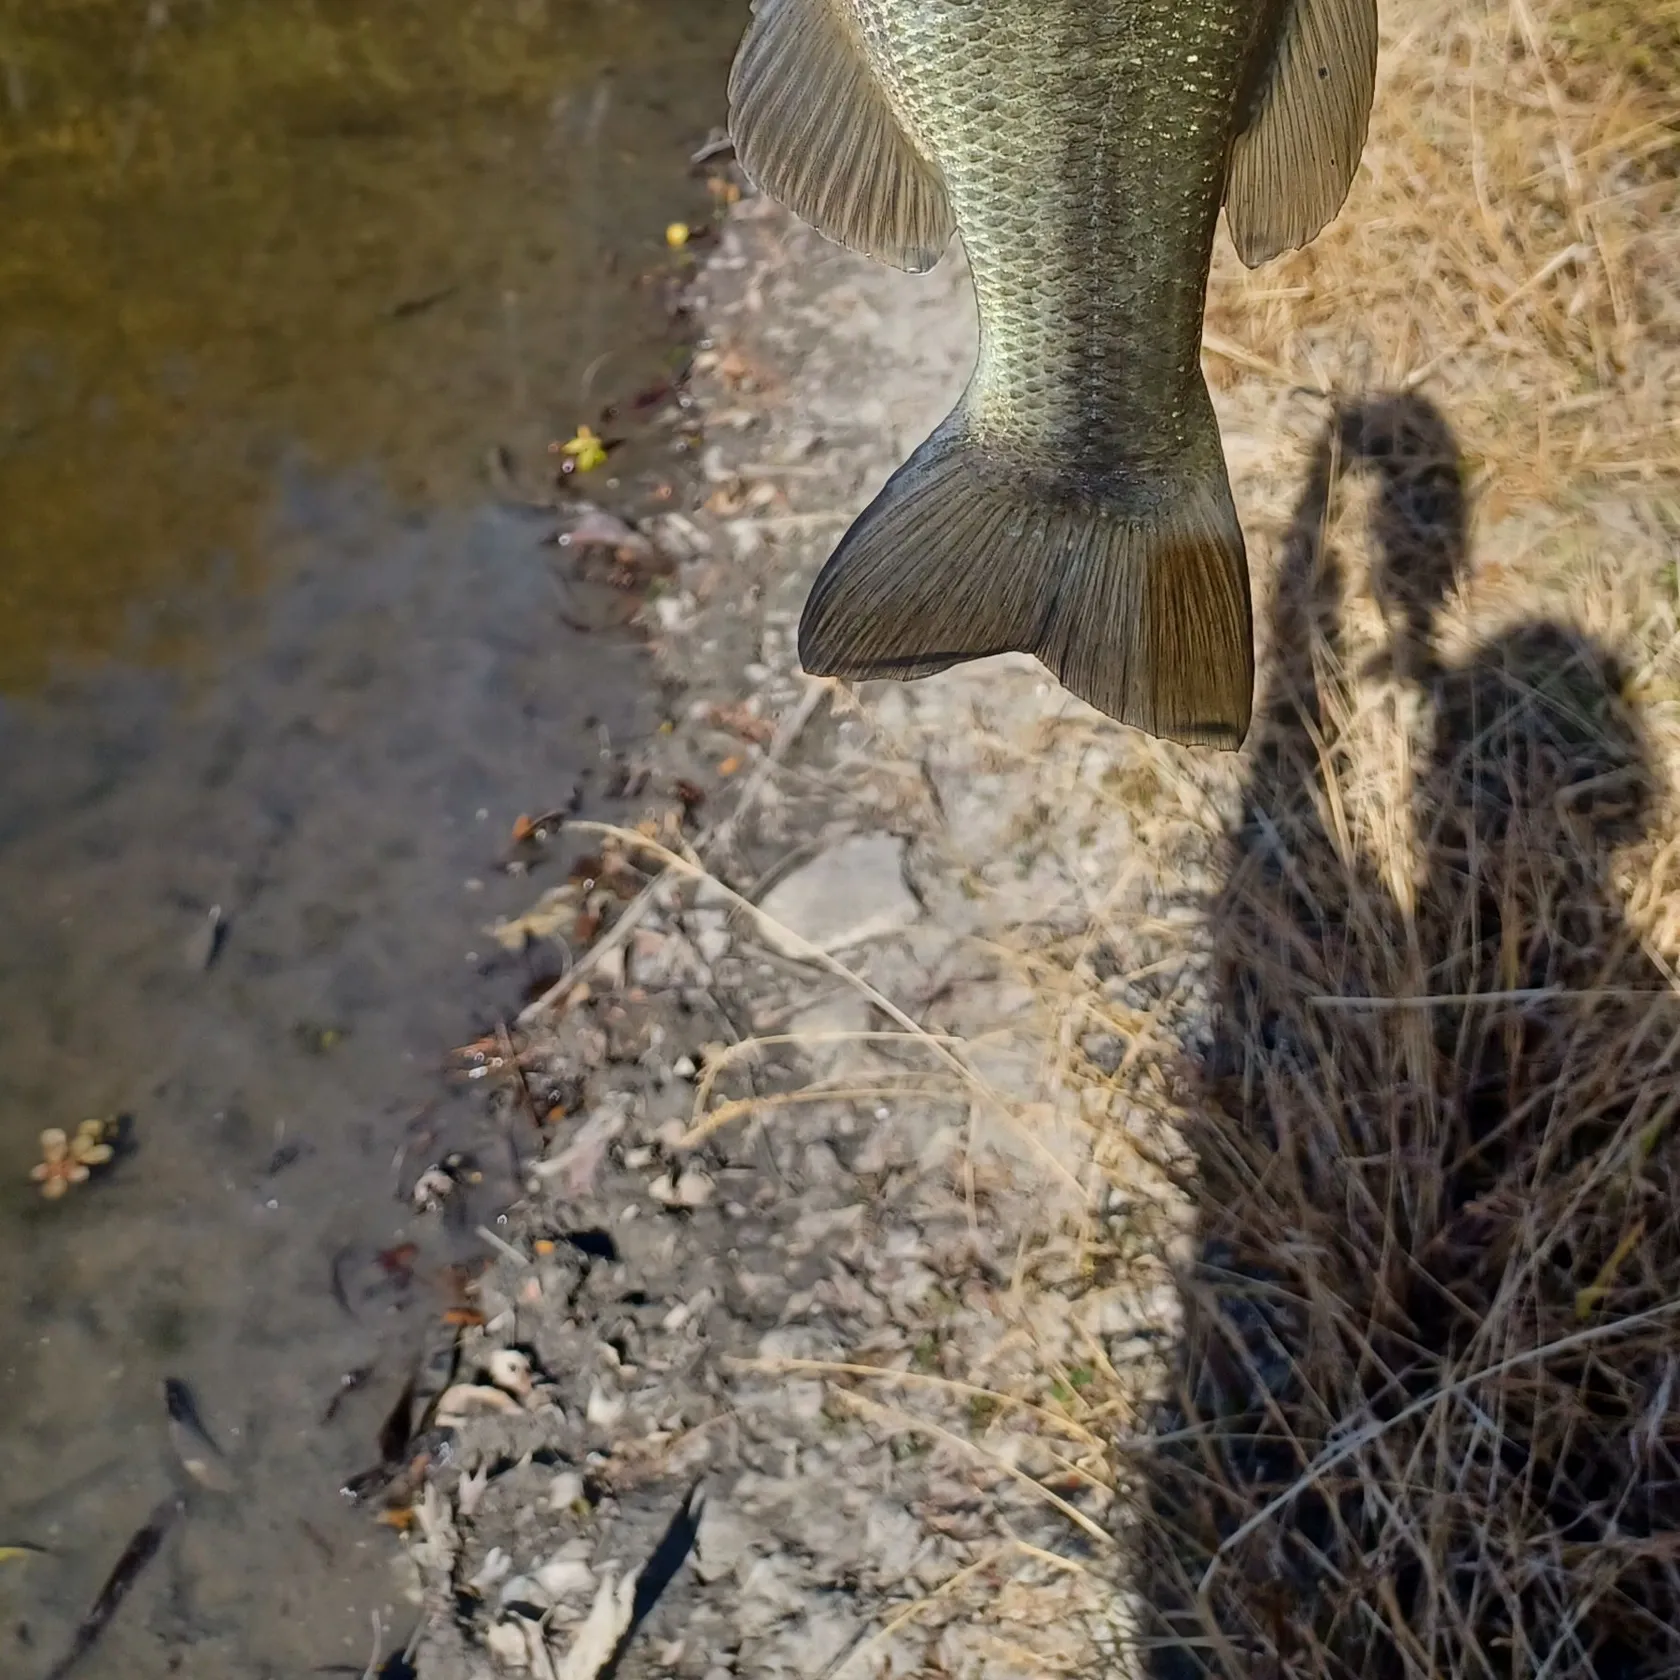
[403,200,1159,1677]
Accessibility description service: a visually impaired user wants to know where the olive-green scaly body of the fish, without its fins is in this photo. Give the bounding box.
[848,0,1277,490]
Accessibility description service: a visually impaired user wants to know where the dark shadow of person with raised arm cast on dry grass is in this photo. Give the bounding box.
[1126,398,1680,1677]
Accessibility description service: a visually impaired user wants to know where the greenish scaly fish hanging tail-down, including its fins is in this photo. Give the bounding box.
[729,0,1378,749]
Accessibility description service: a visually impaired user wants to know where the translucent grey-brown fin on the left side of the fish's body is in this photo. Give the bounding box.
[729,0,956,274]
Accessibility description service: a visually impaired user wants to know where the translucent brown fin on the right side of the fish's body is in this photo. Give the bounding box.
[1225,0,1376,269]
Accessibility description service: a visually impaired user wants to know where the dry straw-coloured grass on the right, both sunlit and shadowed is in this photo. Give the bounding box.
[1032,0,1680,1680]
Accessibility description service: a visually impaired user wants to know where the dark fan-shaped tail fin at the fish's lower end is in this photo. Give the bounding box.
[800,412,1253,748]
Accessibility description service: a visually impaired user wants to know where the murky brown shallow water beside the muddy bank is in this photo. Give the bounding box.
[0,0,744,1680]
